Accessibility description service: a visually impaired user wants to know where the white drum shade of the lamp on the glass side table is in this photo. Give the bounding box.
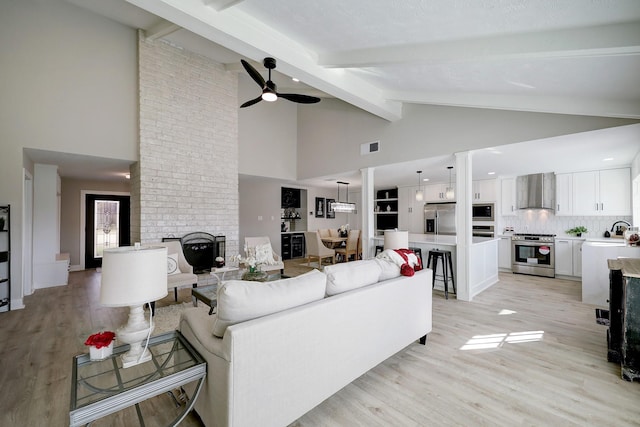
[100,246,167,307]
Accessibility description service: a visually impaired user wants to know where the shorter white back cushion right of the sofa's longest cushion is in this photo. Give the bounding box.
[323,259,382,296]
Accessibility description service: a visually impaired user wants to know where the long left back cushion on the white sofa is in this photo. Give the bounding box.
[213,270,327,338]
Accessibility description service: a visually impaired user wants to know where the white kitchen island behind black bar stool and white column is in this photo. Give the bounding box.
[373,233,500,299]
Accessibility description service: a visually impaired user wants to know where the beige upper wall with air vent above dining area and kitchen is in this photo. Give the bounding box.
[298,99,637,179]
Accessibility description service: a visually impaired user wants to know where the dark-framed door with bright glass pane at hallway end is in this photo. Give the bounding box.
[84,194,131,268]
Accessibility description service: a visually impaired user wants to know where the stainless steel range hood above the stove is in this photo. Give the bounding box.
[516,173,556,210]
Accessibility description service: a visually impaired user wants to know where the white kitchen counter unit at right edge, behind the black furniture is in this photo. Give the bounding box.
[582,238,640,307]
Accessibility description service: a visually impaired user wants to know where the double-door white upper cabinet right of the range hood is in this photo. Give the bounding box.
[573,168,631,216]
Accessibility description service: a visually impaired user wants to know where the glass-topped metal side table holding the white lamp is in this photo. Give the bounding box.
[69,331,207,427]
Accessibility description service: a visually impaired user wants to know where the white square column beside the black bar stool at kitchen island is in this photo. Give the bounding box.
[455,151,473,301]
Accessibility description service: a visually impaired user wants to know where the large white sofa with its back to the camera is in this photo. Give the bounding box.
[180,260,432,427]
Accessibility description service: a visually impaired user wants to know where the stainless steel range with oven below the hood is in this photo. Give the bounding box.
[511,233,556,277]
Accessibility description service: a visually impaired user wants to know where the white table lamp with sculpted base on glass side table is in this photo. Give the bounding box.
[100,244,167,368]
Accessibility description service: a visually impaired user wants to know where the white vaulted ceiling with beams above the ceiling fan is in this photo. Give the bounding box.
[61,0,640,186]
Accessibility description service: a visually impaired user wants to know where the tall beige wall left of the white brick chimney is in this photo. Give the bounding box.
[0,0,138,308]
